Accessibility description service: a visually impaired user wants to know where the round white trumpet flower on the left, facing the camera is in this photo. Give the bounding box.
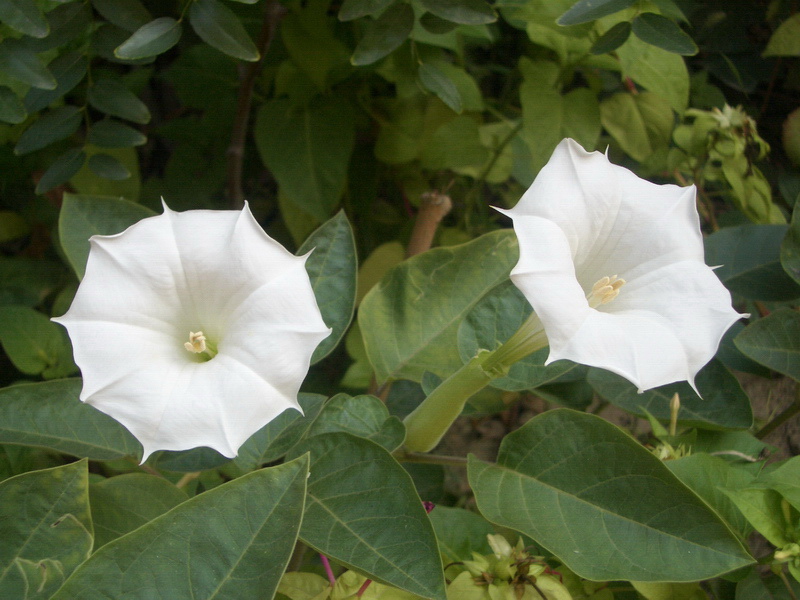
[54,205,330,462]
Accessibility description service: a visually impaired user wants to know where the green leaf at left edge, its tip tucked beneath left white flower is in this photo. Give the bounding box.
[0,379,142,460]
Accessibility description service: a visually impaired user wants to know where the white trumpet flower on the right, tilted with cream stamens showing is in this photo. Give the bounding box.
[502,140,744,391]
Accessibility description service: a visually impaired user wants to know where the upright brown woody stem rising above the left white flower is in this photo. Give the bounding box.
[227,0,287,209]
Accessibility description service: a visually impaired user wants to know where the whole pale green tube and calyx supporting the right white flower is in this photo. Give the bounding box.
[404,315,547,452]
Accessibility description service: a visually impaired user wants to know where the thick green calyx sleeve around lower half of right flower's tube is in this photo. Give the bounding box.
[404,351,494,452]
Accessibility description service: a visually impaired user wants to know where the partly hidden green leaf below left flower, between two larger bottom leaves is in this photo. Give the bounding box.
[89,473,187,550]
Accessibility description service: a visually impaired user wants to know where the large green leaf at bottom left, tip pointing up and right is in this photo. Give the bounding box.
[53,457,308,600]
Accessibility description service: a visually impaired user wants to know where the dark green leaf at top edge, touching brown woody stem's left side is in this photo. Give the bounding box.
[189,0,259,61]
